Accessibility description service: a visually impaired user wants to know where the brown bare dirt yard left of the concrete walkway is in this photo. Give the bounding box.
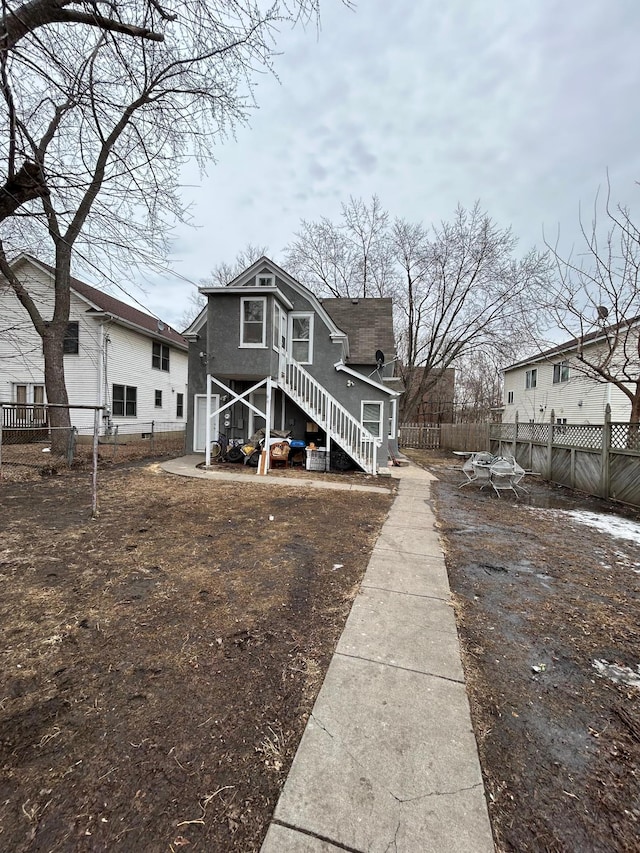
[0,464,392,853]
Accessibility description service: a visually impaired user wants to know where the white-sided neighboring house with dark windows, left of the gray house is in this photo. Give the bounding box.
[0,254,188,435]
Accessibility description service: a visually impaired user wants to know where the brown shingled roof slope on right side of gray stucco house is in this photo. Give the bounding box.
[322,297,396,364]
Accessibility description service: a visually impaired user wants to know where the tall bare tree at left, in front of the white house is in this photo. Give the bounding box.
[0,0,318,450]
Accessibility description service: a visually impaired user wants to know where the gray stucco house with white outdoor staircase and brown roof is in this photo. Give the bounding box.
[184,257,401,474]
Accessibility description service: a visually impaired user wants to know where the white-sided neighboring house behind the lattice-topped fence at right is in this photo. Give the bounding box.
[502,324,640,424]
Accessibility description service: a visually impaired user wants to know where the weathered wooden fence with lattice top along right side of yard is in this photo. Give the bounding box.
[490,406,640,506]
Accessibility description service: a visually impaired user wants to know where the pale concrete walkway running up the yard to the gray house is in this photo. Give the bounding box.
[162,458,494,853]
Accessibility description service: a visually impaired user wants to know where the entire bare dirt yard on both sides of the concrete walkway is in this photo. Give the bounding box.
[0,452,640,853]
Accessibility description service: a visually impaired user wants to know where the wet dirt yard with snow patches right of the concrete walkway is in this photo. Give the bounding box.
[407,451,640,853]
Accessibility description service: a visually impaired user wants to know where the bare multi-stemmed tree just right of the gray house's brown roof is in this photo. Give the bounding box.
[395,204,547,421]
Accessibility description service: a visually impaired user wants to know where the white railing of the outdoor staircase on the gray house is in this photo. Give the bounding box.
[278,358,378,474]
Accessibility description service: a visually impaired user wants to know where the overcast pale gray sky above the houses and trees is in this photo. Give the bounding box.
[132,0,640,325]
